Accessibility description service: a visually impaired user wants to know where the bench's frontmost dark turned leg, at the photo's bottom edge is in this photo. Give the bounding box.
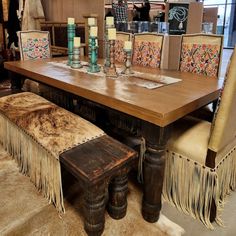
[84,183,105,236]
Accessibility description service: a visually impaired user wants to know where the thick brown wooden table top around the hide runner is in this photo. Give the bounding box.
[4,58,222,127]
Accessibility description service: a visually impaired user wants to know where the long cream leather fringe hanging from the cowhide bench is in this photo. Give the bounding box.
[0,114,65,212]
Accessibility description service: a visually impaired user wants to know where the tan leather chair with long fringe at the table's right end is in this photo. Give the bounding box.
[163,49,236,228]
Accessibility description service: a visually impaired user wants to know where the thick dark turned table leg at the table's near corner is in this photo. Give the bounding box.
[142,122,169,223]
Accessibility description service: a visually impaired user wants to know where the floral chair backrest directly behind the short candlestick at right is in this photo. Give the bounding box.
[132,33,164,68]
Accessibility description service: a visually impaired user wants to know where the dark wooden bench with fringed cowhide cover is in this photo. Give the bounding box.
[0,92,137,235]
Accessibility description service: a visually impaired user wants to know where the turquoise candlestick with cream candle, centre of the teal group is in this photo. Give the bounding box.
[88,26,100,73]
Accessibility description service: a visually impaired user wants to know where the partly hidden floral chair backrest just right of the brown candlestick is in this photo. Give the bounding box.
[115,31,132,63]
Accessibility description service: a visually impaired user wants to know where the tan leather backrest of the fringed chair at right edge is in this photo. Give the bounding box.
[208,49,236,153]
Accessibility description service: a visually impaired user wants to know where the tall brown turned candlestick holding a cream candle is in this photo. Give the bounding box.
[106,28,118,77]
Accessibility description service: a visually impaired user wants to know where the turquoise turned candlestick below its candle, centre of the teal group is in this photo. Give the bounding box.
[87,36,100,73]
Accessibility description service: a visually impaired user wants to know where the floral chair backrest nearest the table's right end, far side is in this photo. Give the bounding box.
[180,34,223,77]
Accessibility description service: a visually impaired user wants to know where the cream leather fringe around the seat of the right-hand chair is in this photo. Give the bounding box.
[163,148,236,229]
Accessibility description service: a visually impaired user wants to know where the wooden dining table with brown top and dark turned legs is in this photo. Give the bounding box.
[4,58,222,222]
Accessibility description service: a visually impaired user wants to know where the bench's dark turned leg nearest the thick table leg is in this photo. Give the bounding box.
[107,171,128,219]
